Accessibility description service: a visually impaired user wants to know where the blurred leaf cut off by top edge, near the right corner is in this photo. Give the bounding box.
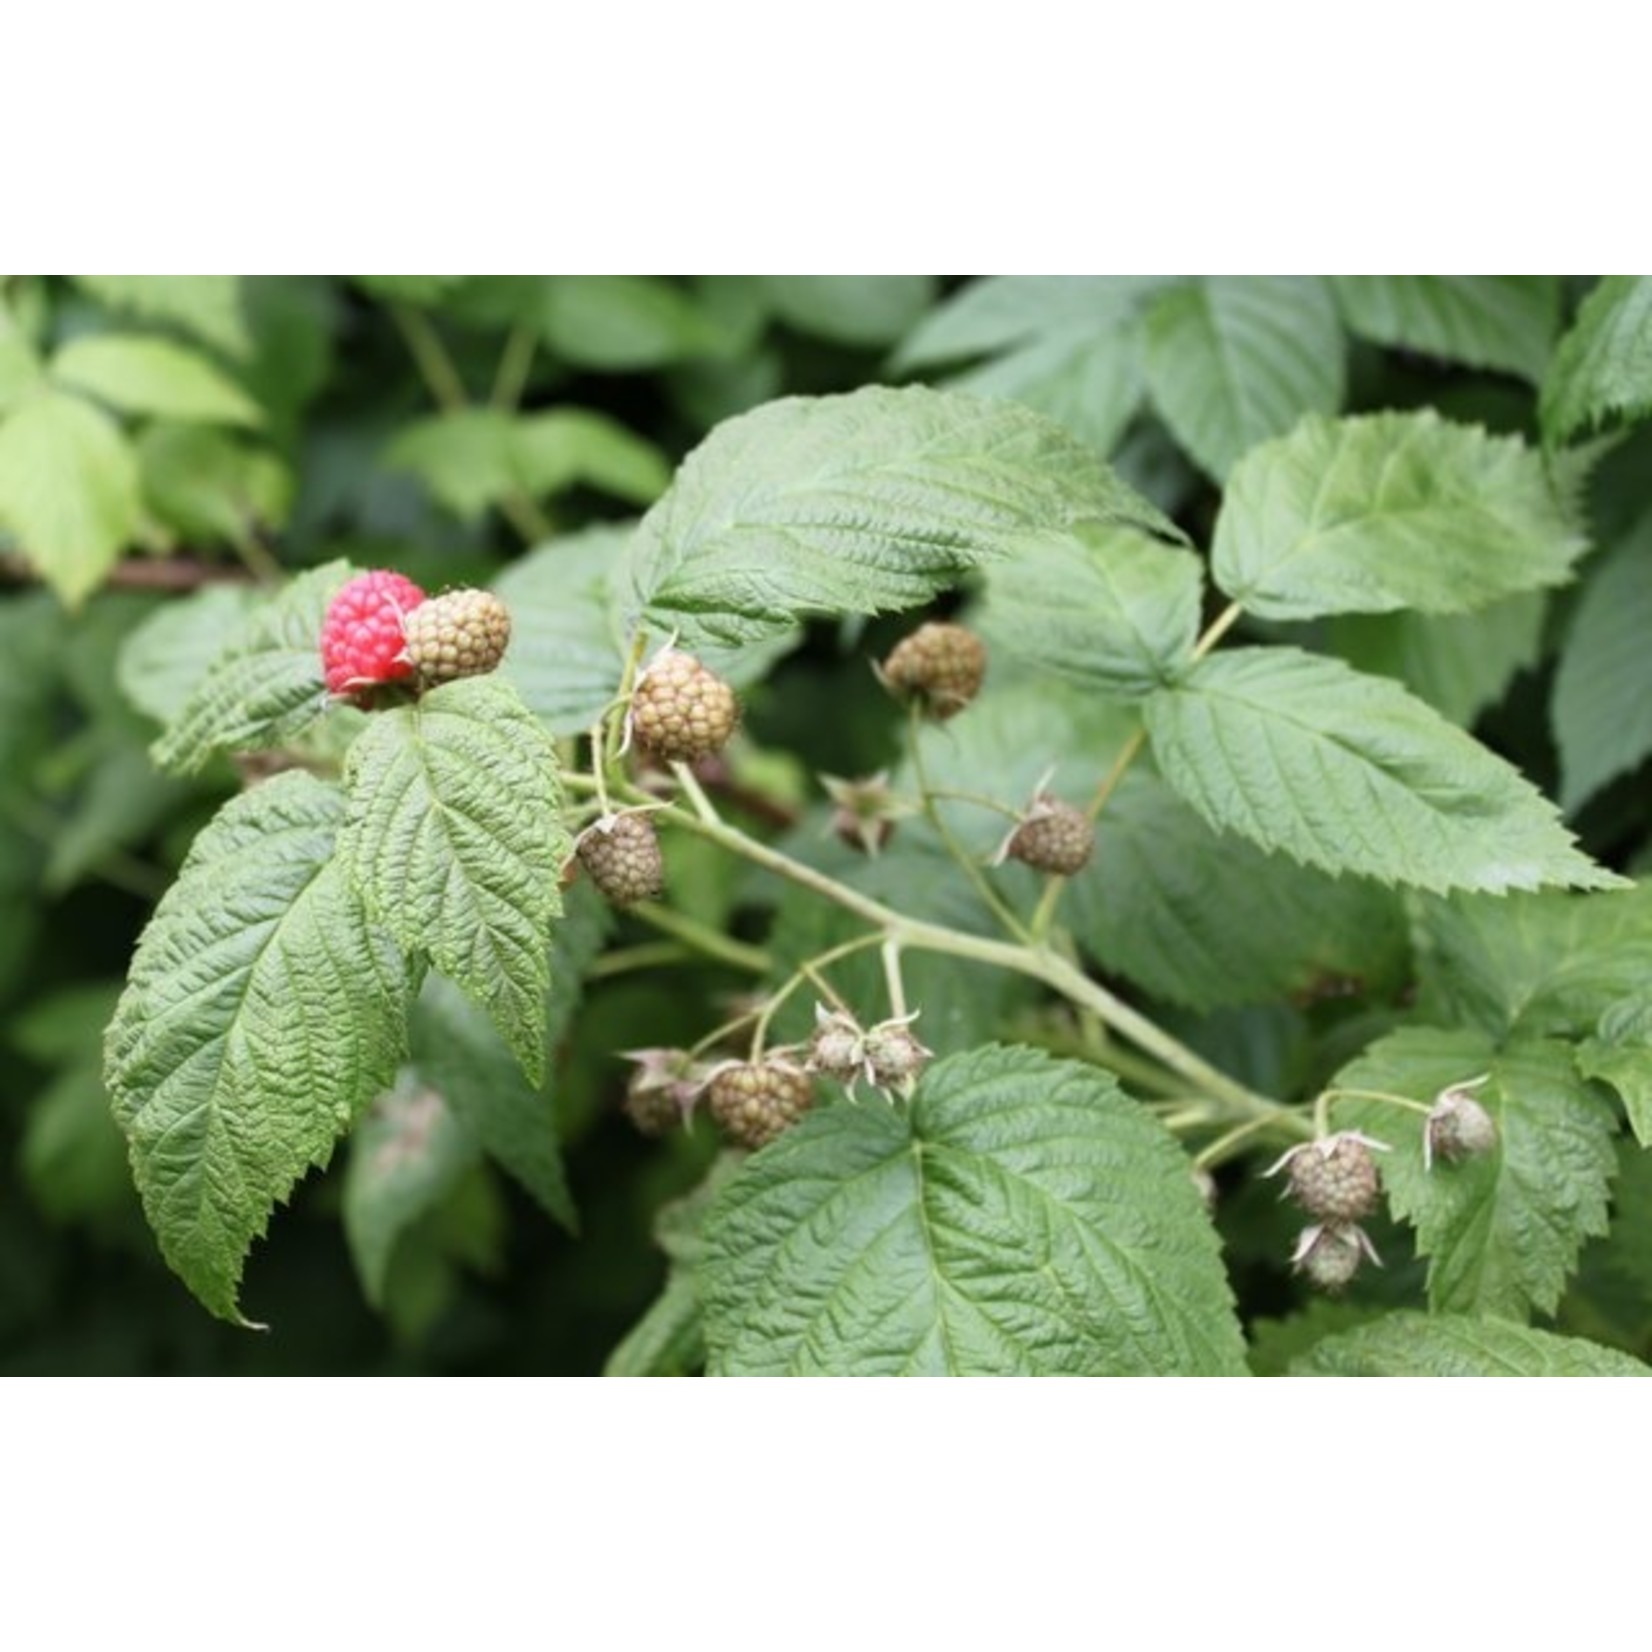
[1332,276,1559,383]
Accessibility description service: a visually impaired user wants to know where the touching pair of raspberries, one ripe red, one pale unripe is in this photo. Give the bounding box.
[320,568,510,700]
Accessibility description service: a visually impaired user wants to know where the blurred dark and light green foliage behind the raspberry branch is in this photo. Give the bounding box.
[0,276,1652,1373]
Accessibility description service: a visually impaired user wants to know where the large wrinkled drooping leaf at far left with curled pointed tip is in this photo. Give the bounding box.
[106,773,410,1320]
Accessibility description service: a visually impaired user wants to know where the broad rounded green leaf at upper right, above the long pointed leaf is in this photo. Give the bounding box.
[1211,411,1584,620]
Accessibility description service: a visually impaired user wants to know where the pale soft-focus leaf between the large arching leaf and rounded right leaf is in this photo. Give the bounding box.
[978,522,1204,699]
